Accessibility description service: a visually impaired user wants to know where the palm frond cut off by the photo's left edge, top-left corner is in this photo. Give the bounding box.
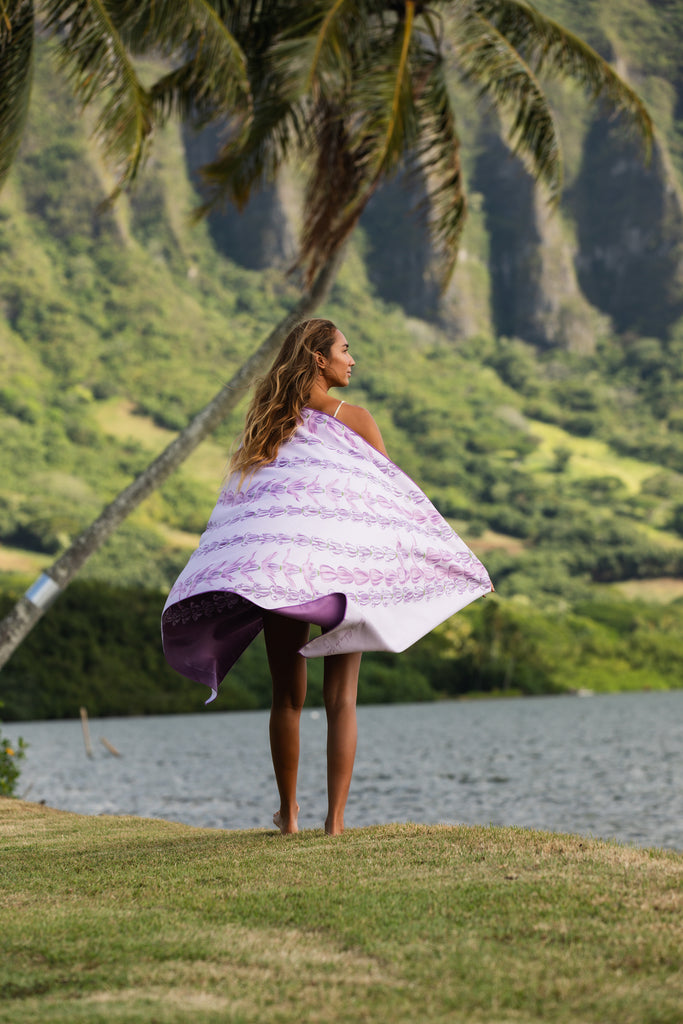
[0,0,34,185]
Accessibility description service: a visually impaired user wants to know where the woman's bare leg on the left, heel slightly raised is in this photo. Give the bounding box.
[263,612,308,836]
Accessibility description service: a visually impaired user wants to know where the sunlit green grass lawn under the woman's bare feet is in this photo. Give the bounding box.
[0,799,683,1024]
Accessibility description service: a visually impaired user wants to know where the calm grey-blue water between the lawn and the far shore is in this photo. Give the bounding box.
[12,691,683,850]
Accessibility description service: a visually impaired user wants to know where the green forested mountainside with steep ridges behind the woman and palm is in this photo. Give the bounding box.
[0,0,683,719]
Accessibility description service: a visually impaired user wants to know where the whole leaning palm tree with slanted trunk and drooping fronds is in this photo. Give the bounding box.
[0,0,652,666]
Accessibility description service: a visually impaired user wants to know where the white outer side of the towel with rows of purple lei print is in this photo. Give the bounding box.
[162,410,487,614]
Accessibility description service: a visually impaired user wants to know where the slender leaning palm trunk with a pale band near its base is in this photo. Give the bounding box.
[0,253,342,669]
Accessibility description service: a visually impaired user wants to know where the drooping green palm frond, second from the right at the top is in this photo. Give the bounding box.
[454,0,562,203]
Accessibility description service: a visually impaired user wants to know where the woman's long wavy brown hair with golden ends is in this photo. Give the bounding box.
[228,318,337,486]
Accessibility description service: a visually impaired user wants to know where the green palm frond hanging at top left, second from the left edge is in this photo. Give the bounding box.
[43,0,155,199]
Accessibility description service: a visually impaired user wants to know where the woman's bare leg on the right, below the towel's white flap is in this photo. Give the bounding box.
[323,654,360,836]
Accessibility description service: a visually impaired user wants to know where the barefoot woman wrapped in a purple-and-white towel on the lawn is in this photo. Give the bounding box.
[162,319,492,836]
